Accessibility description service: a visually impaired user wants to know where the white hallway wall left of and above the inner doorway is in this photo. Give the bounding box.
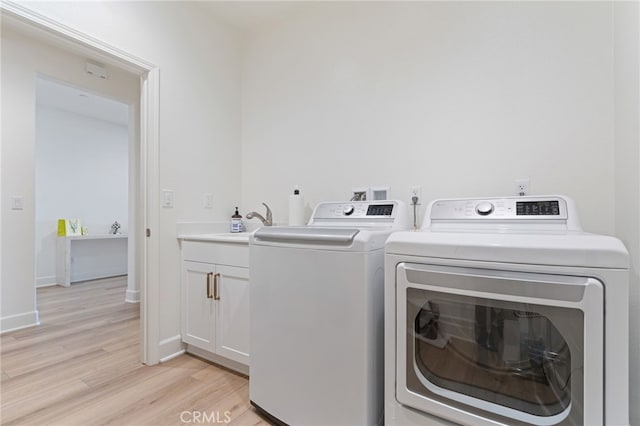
[0,25,139,331]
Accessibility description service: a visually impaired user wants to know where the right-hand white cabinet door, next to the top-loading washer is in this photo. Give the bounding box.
[216,265,249,365]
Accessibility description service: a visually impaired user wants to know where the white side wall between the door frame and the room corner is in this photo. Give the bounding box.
[2,2,241,358]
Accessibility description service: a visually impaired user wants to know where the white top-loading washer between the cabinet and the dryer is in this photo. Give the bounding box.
[249,201,409,425]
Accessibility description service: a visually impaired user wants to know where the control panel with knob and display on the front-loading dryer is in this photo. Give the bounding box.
[430,196,567,221]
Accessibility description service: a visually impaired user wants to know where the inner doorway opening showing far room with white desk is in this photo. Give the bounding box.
[35,75,132,296]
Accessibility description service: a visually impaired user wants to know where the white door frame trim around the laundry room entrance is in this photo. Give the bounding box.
[0,0,160,365]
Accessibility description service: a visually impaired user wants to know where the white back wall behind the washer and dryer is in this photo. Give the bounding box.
[242,1,614,234]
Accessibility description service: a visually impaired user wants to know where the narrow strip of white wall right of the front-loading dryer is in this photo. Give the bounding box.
[613,1,640,425]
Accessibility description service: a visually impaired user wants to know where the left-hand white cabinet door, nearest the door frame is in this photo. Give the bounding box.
[182,261,216,352]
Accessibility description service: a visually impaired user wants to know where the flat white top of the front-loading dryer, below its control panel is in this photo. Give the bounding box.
[385,231,629,269]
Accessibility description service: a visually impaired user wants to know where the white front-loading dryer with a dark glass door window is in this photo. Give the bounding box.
[385,196,629,426]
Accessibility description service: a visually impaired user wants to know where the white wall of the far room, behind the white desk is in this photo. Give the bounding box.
[35,105,129,286]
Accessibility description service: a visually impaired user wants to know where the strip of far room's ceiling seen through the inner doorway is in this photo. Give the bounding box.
[36,77,129,126]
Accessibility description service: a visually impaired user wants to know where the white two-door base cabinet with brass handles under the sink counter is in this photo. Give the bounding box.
[181,240,249,369]
